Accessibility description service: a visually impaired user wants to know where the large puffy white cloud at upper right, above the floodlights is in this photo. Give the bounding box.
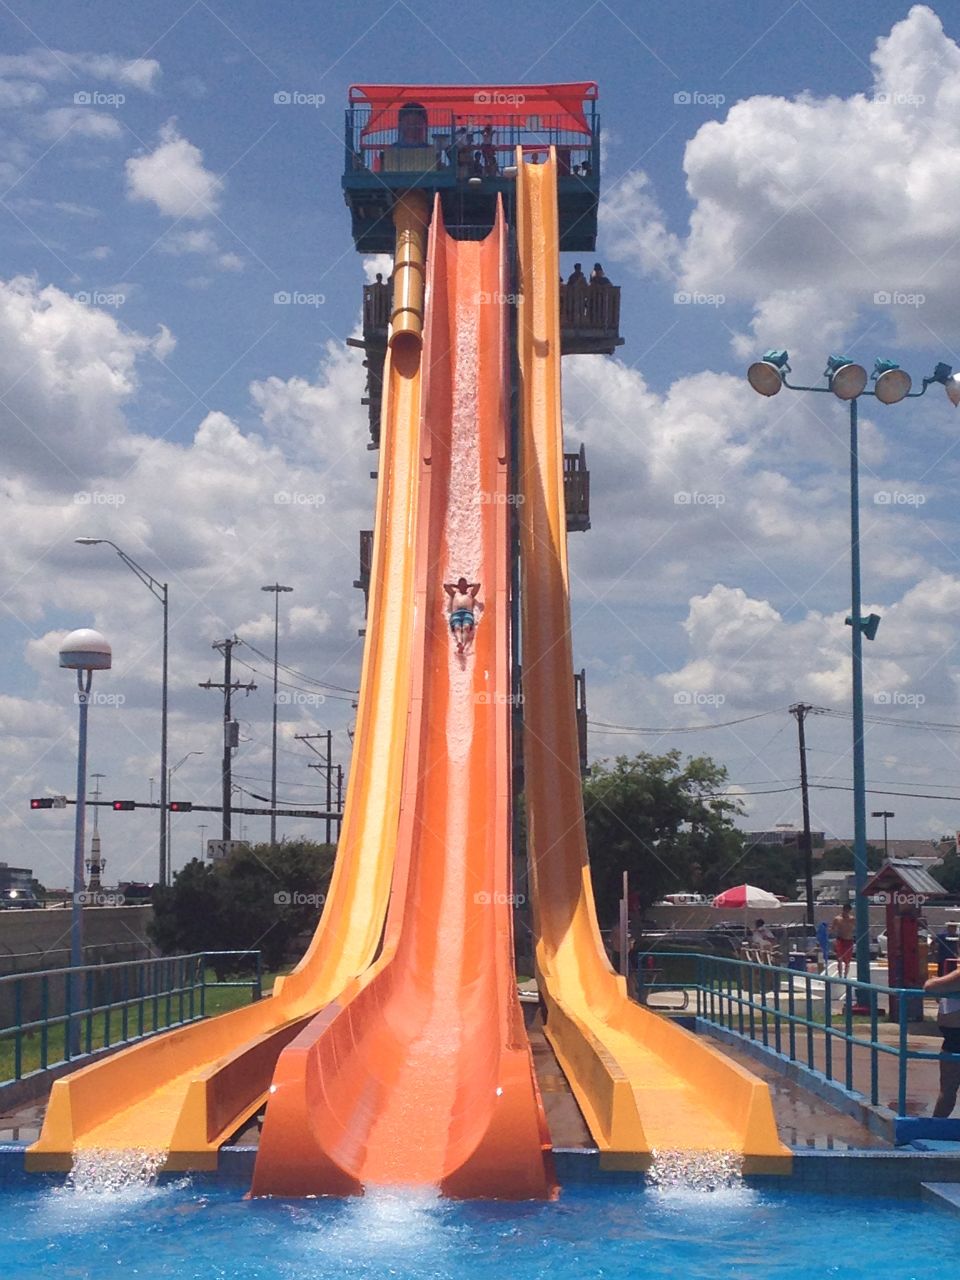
[602,5,960,358]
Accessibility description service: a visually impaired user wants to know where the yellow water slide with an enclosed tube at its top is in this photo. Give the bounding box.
[27,197,426,1170]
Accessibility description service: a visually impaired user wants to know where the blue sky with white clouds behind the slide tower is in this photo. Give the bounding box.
[0,0,960,883]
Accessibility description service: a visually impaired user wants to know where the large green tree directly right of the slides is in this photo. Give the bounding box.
[584,751,744,922]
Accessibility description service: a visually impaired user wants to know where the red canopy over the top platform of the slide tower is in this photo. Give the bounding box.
[349,81,596,134]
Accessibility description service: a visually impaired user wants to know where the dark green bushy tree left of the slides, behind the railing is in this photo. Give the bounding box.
[150,841,335,974]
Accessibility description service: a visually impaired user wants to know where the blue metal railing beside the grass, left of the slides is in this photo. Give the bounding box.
[0,951,262,1085]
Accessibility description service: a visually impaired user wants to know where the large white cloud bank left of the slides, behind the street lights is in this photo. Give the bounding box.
[0,271,374,884]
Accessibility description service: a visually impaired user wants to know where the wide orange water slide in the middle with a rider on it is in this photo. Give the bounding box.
[252,201,554,1198]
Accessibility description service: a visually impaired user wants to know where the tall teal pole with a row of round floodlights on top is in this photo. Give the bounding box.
[746,349,960,987]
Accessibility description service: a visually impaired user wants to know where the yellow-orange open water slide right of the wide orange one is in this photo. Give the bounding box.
[517,152,790,1172]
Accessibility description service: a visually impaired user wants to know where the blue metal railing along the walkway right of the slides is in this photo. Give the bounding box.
[637,951,960,1116]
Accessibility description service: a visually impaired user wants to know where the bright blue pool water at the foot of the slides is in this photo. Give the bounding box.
[0,1178,960,1280]
